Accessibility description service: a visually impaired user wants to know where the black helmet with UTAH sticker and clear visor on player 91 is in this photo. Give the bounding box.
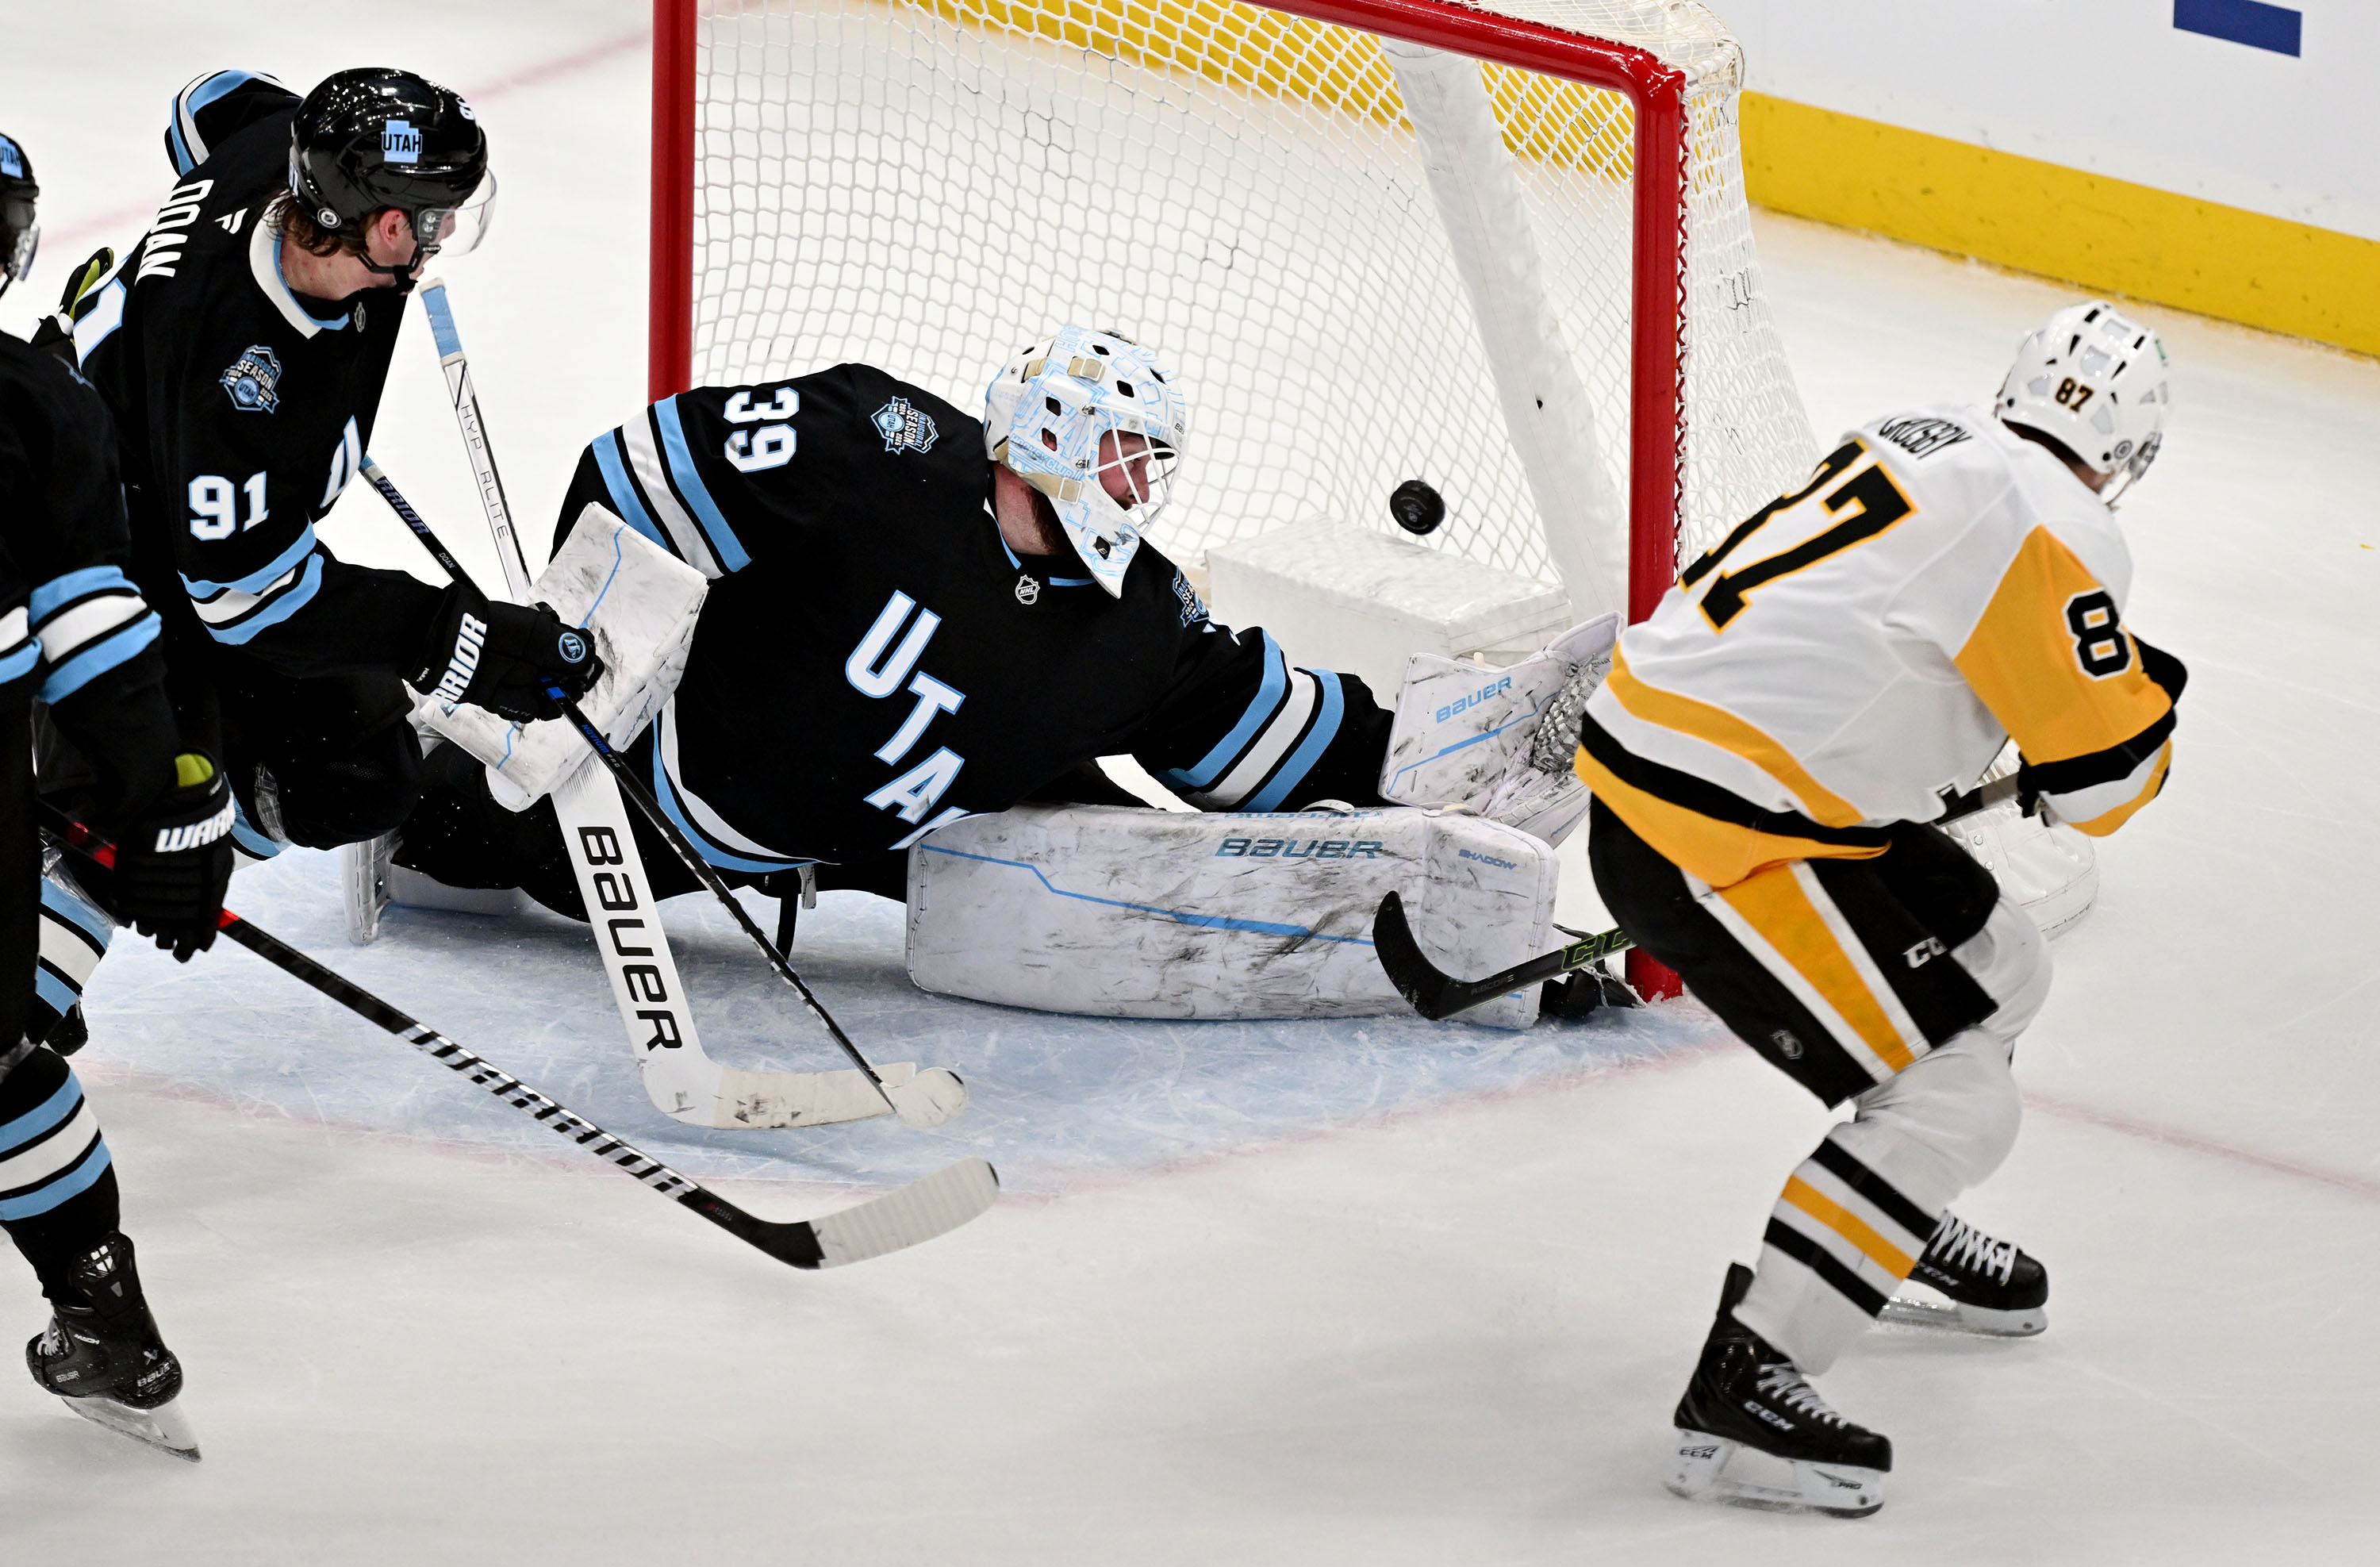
[290,67,495,274]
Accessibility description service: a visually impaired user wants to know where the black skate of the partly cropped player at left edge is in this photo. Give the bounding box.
[24,1234,198,1465]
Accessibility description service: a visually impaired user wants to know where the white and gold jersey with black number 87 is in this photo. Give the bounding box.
[1578,407,2182,886]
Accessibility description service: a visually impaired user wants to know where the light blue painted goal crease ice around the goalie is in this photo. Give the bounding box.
[88,851,1711,1193]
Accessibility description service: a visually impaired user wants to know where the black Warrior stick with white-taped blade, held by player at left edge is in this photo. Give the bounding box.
[40,805,1000,1269]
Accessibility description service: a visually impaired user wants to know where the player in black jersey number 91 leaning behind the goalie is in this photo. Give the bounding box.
[34,69,593,1033]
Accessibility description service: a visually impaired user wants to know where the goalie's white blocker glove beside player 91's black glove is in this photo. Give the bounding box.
[414,502,709,810]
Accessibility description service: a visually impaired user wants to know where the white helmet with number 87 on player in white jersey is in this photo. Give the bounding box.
[1994,300,2173,505]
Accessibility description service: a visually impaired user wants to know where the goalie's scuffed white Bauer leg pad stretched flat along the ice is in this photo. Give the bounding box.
[909,805,1554,1029]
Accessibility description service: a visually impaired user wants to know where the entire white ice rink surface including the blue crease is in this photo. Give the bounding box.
[0,0,2380,1567]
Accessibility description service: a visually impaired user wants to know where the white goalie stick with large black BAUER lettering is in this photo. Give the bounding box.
[405,278,966,1127]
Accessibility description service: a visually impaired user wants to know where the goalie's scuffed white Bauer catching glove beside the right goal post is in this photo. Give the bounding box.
[1380,614,1621,846]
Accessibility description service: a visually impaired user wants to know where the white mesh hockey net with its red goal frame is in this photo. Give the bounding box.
[652,0,1816,616]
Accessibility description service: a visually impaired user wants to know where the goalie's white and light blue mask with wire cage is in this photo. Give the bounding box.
[983,326,1188,597]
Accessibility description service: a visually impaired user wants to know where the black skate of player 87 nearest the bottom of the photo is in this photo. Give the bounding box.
[1668,1262,1892,1517]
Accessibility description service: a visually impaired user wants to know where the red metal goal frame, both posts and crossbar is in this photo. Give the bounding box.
[645,0,1687,621]
